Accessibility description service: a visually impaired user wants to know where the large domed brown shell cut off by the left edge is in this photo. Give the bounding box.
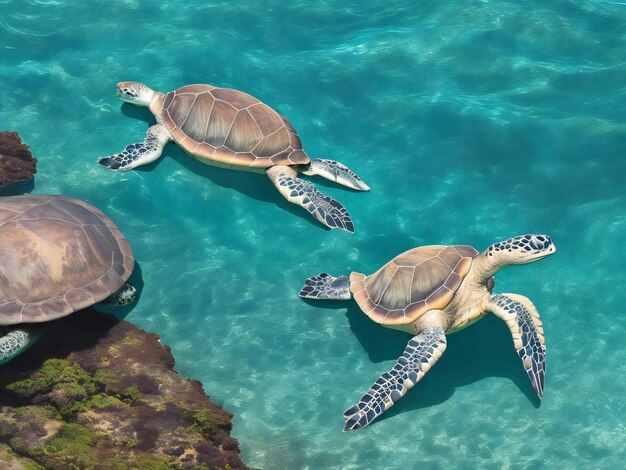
[0,195,135,325]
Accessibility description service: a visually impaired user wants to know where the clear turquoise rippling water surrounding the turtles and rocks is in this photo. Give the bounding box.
[0,1,626,469]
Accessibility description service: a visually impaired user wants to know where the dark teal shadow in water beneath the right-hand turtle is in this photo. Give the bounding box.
[332,301,540,421]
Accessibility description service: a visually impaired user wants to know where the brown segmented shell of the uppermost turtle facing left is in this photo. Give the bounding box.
[161,85,310,168]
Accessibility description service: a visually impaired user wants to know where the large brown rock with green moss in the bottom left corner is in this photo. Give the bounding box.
[0,309,247,470]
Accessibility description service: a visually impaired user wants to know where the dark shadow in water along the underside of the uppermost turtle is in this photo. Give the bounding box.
[121,103,358,231]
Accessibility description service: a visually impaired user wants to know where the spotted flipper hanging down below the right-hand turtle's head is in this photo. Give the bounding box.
[487,294,546,400]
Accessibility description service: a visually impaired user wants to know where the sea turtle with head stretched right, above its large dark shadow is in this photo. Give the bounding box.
[300,235,556,431]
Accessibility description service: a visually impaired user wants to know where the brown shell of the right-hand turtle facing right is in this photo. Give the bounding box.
[350,245,478,325]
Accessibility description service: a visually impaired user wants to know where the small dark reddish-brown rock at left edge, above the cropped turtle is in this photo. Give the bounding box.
[0,131,37,186]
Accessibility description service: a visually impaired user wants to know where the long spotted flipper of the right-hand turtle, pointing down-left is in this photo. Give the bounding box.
[343,327,447,431]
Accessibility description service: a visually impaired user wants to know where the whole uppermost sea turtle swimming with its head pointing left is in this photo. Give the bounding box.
[98,82,369,232]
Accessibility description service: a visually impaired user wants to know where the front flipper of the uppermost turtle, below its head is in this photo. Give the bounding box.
[98,124,171,171]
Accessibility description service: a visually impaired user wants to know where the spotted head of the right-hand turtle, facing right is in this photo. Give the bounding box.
[485,234,556,265]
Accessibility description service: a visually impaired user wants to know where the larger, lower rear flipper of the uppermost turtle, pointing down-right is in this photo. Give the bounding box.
[266,165,354,233]
